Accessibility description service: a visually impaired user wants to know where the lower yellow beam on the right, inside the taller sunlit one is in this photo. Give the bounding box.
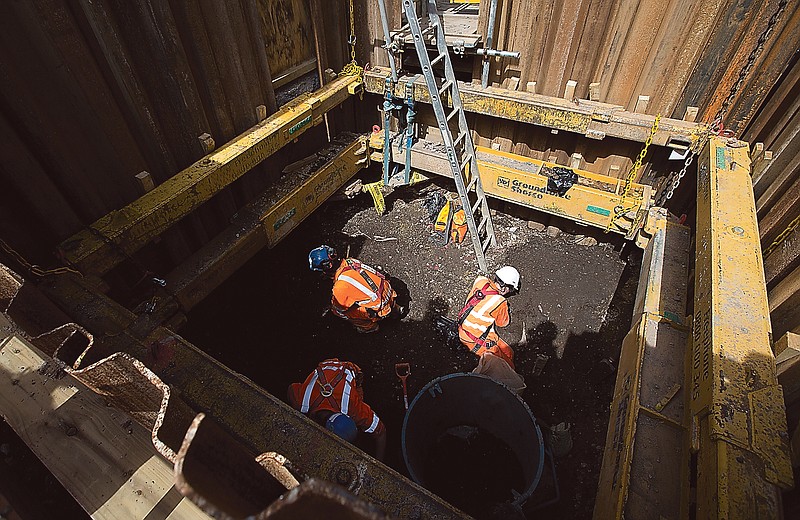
[594,208,691,520]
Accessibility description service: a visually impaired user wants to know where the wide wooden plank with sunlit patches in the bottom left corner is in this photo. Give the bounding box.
[0,330,208,520]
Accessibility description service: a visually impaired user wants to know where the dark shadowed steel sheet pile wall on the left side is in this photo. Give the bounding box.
[0,0,343,272]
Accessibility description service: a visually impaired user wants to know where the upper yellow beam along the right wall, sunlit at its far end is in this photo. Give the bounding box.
[690,137,793,519]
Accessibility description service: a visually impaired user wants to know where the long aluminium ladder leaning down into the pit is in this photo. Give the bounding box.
[403,0,497,273]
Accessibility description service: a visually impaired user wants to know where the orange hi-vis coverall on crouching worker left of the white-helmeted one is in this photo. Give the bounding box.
[331,258,397,332]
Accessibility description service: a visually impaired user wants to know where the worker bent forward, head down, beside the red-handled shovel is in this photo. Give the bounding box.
[288,358,386,459]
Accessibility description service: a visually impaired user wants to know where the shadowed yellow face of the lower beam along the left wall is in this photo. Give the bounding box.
[261,136,369,247]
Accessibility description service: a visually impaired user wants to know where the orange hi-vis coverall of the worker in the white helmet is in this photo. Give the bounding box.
[458,276,514,368]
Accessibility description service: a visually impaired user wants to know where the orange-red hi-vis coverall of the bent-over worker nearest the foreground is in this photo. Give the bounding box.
[288,358,385,435]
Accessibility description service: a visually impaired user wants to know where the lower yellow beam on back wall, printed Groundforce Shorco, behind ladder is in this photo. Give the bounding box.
[370,133,652,238]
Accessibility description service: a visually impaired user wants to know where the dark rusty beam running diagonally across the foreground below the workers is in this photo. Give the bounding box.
[40,274,468,519]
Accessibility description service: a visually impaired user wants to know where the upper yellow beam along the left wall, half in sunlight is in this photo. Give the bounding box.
[60,76,359,275]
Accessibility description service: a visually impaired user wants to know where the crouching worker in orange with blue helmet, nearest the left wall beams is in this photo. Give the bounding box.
[308,245,404,334]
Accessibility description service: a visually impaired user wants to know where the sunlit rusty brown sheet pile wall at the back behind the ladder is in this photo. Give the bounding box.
[364,0,800,180]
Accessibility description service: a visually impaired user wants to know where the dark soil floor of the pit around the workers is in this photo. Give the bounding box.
[181,176,641,518]
